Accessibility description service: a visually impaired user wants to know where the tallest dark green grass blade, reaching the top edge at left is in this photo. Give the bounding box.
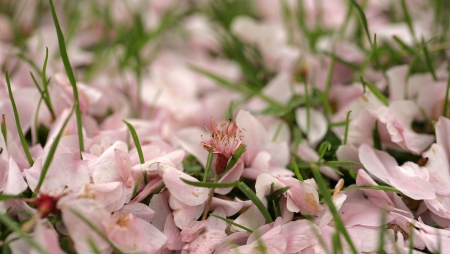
[49,0,84,158]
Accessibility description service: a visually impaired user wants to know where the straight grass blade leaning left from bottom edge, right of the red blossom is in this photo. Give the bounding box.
[311,164,358,254]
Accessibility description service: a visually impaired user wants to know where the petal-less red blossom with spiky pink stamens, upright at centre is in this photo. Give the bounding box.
[201,120,243,174]
